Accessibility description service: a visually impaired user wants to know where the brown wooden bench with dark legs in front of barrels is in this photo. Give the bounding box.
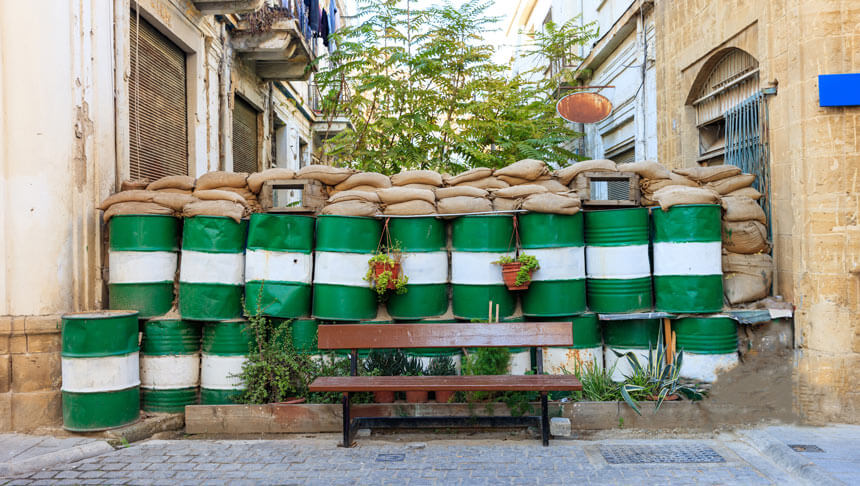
[310,322,582,447]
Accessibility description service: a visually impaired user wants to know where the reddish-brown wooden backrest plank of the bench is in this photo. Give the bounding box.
[318,322,573,349]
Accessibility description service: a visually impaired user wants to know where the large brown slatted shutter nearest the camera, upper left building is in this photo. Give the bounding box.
[128,10,188,180]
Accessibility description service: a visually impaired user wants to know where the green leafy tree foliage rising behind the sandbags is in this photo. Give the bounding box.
[316,0,593,174]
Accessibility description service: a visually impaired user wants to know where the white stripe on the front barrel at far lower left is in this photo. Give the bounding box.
[62,351,140,393]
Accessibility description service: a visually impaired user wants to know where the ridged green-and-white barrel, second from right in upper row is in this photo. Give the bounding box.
[585,208,652,314]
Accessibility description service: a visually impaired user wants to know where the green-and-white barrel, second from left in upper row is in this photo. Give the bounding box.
[179,216,248,321]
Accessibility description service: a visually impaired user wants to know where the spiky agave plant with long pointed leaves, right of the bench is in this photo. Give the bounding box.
[613,326,702,415]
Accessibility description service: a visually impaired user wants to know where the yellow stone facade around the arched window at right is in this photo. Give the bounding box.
[655,0,860,423]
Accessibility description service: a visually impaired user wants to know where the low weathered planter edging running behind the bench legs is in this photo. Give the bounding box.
[185,402,784,434]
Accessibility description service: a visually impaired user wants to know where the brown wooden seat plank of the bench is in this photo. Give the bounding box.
[309,375,582,392]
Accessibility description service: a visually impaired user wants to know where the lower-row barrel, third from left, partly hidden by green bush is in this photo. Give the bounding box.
[200,319,253,405]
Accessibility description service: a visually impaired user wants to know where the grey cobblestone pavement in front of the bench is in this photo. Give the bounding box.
[0,436,799,486]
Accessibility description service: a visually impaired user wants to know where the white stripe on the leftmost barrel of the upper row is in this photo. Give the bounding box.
[108,250,177,284]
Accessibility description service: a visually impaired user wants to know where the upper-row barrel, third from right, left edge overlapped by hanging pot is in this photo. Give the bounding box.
[518,212,586,317]
